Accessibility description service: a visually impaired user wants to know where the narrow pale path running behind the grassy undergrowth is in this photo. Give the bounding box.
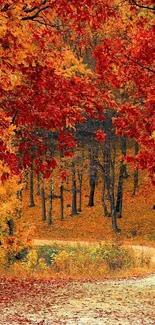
[32,239,155,264]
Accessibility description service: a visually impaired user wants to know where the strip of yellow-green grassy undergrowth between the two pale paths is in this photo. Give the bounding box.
[1,242,154,279]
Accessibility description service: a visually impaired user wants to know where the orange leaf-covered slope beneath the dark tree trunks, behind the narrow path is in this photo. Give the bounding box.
[21,180,155,246]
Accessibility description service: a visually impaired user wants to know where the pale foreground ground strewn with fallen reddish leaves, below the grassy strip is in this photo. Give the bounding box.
[0,275,155,325]
